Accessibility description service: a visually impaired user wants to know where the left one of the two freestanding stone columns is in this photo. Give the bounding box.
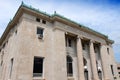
[77,37,85,80]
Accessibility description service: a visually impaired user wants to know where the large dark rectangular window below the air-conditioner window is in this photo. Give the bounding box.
[33,57,43,77]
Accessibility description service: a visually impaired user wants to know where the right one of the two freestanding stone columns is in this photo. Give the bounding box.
[90,40,99,80]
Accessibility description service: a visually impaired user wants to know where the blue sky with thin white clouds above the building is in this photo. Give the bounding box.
[0,0,120,62]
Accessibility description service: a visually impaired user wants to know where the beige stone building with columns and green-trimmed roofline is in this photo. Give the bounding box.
[0,3,118,80]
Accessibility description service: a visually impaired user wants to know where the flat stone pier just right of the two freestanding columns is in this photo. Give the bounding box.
[100,44,109,80]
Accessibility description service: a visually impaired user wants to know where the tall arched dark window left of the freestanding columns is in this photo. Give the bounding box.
[67,56,73,76]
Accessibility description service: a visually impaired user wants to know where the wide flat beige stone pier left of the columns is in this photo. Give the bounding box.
[53,29,67,80]
